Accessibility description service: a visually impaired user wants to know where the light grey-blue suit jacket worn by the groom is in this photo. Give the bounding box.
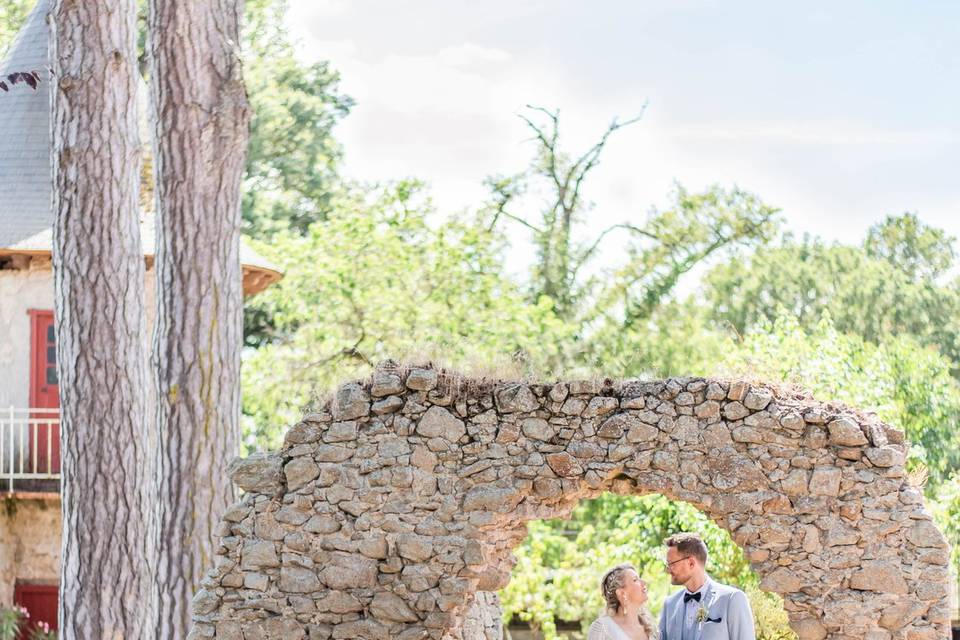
[660,580,756,640]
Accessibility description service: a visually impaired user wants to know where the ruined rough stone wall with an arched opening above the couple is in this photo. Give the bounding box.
[191,367,949,640]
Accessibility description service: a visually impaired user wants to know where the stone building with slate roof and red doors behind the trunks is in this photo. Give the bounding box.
[0,0,280,627]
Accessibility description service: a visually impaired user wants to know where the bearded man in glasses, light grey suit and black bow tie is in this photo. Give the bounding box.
[660,533,756,640]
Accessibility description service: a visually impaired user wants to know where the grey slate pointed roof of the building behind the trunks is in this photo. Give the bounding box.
[0,0,281,294]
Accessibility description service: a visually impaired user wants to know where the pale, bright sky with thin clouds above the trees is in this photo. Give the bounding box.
[288,0,960,250]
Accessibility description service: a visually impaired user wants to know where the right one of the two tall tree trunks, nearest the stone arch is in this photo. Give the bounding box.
[149,0,249,639]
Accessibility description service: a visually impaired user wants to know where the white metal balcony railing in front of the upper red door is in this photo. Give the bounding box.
[0,407,60,492]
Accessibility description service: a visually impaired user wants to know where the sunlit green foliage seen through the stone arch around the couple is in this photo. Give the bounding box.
[496,492,796,640]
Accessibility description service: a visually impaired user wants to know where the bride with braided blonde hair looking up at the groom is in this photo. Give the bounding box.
[587,564,657,640]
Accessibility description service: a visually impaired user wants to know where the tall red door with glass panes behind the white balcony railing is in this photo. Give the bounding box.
[29,309,60,473]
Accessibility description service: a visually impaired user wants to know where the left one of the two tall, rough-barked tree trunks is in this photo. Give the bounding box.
[49,0,152,640]
